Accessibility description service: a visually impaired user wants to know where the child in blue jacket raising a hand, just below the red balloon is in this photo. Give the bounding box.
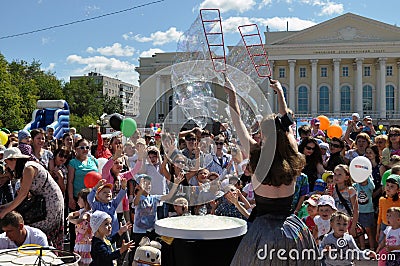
[87,178,127,235]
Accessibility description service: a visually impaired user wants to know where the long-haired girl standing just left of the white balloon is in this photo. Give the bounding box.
[329,164,358,235]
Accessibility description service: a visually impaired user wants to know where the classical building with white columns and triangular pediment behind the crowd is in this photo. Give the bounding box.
[136,13,400,127]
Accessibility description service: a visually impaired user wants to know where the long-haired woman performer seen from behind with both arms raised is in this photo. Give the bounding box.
[225,75,320,265]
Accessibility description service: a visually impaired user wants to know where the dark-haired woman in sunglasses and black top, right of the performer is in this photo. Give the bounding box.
[299,137,325,191]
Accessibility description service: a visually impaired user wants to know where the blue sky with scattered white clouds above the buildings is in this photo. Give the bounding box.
[0,0,400,85]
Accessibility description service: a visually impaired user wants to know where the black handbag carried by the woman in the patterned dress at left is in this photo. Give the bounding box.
[15,174,49,225]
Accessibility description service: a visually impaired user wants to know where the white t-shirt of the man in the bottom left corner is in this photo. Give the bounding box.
[0,225,49,249]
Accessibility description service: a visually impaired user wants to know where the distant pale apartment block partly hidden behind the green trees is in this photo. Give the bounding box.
[70,72,139,117]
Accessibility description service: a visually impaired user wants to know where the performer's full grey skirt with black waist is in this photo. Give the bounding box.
[231,194,320,266]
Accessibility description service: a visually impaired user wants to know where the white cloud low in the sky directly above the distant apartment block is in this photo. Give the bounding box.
[67,55,139,85]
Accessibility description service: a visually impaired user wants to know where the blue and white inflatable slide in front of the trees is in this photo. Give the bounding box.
[24,100,69,139]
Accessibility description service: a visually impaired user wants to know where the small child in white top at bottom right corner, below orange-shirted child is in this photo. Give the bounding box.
[377,207,400,266]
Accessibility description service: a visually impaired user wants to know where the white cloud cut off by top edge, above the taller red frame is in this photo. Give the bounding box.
[200,0,256,13]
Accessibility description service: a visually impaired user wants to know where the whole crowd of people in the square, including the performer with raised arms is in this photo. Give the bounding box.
[0,78,400,265]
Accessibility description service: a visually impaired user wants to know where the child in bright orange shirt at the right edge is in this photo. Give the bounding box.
[376,175,400,244]
